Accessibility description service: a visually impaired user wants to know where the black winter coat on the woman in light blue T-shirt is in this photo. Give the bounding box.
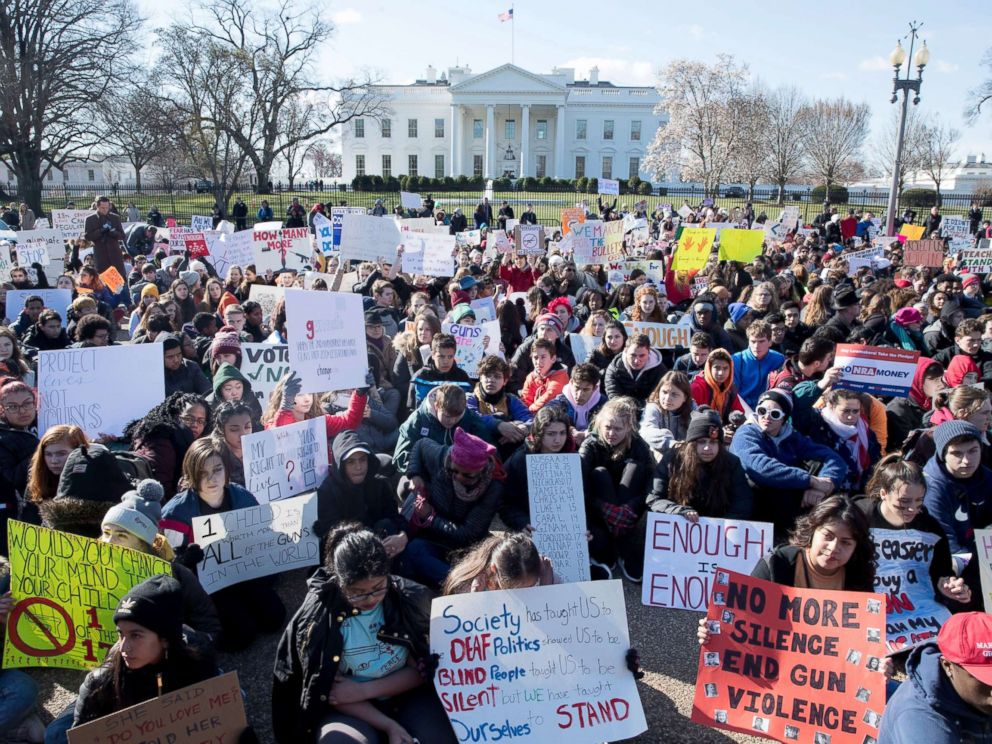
[272,568,431,744]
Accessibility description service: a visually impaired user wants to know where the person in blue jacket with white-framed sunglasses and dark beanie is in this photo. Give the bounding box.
[730,388,847,540]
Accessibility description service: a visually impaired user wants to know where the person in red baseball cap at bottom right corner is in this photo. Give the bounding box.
[870,612,992,744]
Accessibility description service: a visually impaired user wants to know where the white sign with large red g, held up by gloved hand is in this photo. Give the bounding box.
[286,289,369,393]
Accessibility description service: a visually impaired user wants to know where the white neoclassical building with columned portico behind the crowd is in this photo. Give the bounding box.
[341,64,664,182]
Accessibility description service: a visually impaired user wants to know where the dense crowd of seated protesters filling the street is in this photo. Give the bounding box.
[0,193,992,744]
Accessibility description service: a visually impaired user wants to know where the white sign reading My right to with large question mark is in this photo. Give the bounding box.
[241,416,328,502]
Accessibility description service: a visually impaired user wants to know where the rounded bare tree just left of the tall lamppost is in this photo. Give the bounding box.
[799,97,871,198]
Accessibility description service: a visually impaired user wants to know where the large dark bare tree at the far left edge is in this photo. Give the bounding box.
[0,0,140,214]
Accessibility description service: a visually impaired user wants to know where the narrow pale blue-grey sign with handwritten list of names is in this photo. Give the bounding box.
[524,454,589,582]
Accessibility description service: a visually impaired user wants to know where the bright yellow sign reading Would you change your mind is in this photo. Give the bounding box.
[3,520,172,669]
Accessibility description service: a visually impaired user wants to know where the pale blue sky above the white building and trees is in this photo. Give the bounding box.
[138,0,992,160]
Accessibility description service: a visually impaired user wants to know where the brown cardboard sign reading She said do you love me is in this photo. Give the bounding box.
[67,672,248,744]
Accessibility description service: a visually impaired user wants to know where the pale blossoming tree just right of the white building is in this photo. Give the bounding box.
[644,54,747,196]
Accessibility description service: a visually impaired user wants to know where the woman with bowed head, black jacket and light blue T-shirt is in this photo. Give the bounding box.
[272,523,456,744]
